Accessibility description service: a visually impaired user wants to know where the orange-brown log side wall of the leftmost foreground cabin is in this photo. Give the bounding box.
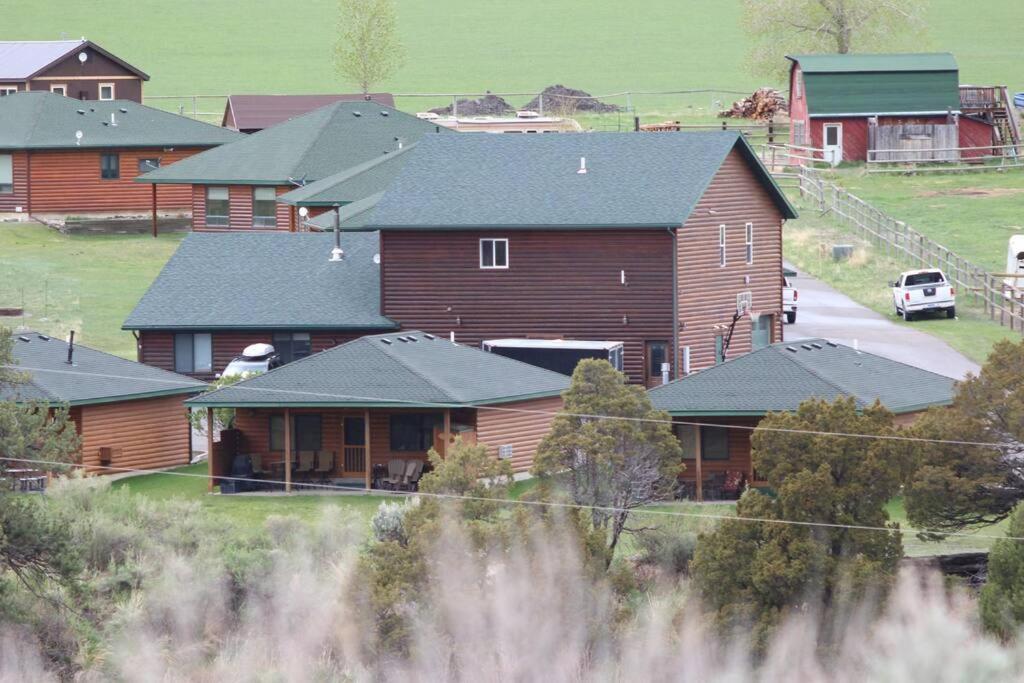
[75,395,190,473]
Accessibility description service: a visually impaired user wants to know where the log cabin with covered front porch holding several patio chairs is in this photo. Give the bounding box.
[188,331,569,490]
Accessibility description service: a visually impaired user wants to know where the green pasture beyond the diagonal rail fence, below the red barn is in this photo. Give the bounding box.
[837,169,1024,272]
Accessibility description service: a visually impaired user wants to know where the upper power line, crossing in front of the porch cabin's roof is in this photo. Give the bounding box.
[3,366,1016,450]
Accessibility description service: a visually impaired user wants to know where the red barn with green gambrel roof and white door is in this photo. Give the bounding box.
[787,52,993,164]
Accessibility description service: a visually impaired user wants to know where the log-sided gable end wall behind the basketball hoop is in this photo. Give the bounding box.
[677,146,782,370]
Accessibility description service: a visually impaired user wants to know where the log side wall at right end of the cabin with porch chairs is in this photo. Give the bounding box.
[476,396,562,473]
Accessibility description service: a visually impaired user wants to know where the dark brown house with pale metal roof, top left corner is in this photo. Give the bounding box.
[0,38,150,103]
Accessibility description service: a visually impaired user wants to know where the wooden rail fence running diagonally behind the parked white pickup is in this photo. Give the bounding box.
[800,167,1024,334]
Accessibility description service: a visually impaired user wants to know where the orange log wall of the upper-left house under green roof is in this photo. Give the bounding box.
[27,147,203,214]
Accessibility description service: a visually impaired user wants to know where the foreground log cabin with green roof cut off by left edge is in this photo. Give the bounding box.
[0,332,206,474]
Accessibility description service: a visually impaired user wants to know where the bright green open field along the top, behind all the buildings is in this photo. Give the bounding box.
[0,0,1024,111]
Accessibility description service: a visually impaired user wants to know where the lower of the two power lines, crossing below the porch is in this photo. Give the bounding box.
[0,456,1024,541]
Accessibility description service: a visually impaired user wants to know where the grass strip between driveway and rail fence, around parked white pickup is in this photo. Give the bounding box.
[782,196,1020,364]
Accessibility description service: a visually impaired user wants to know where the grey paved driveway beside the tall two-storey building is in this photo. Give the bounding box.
[784,264,979,379]
